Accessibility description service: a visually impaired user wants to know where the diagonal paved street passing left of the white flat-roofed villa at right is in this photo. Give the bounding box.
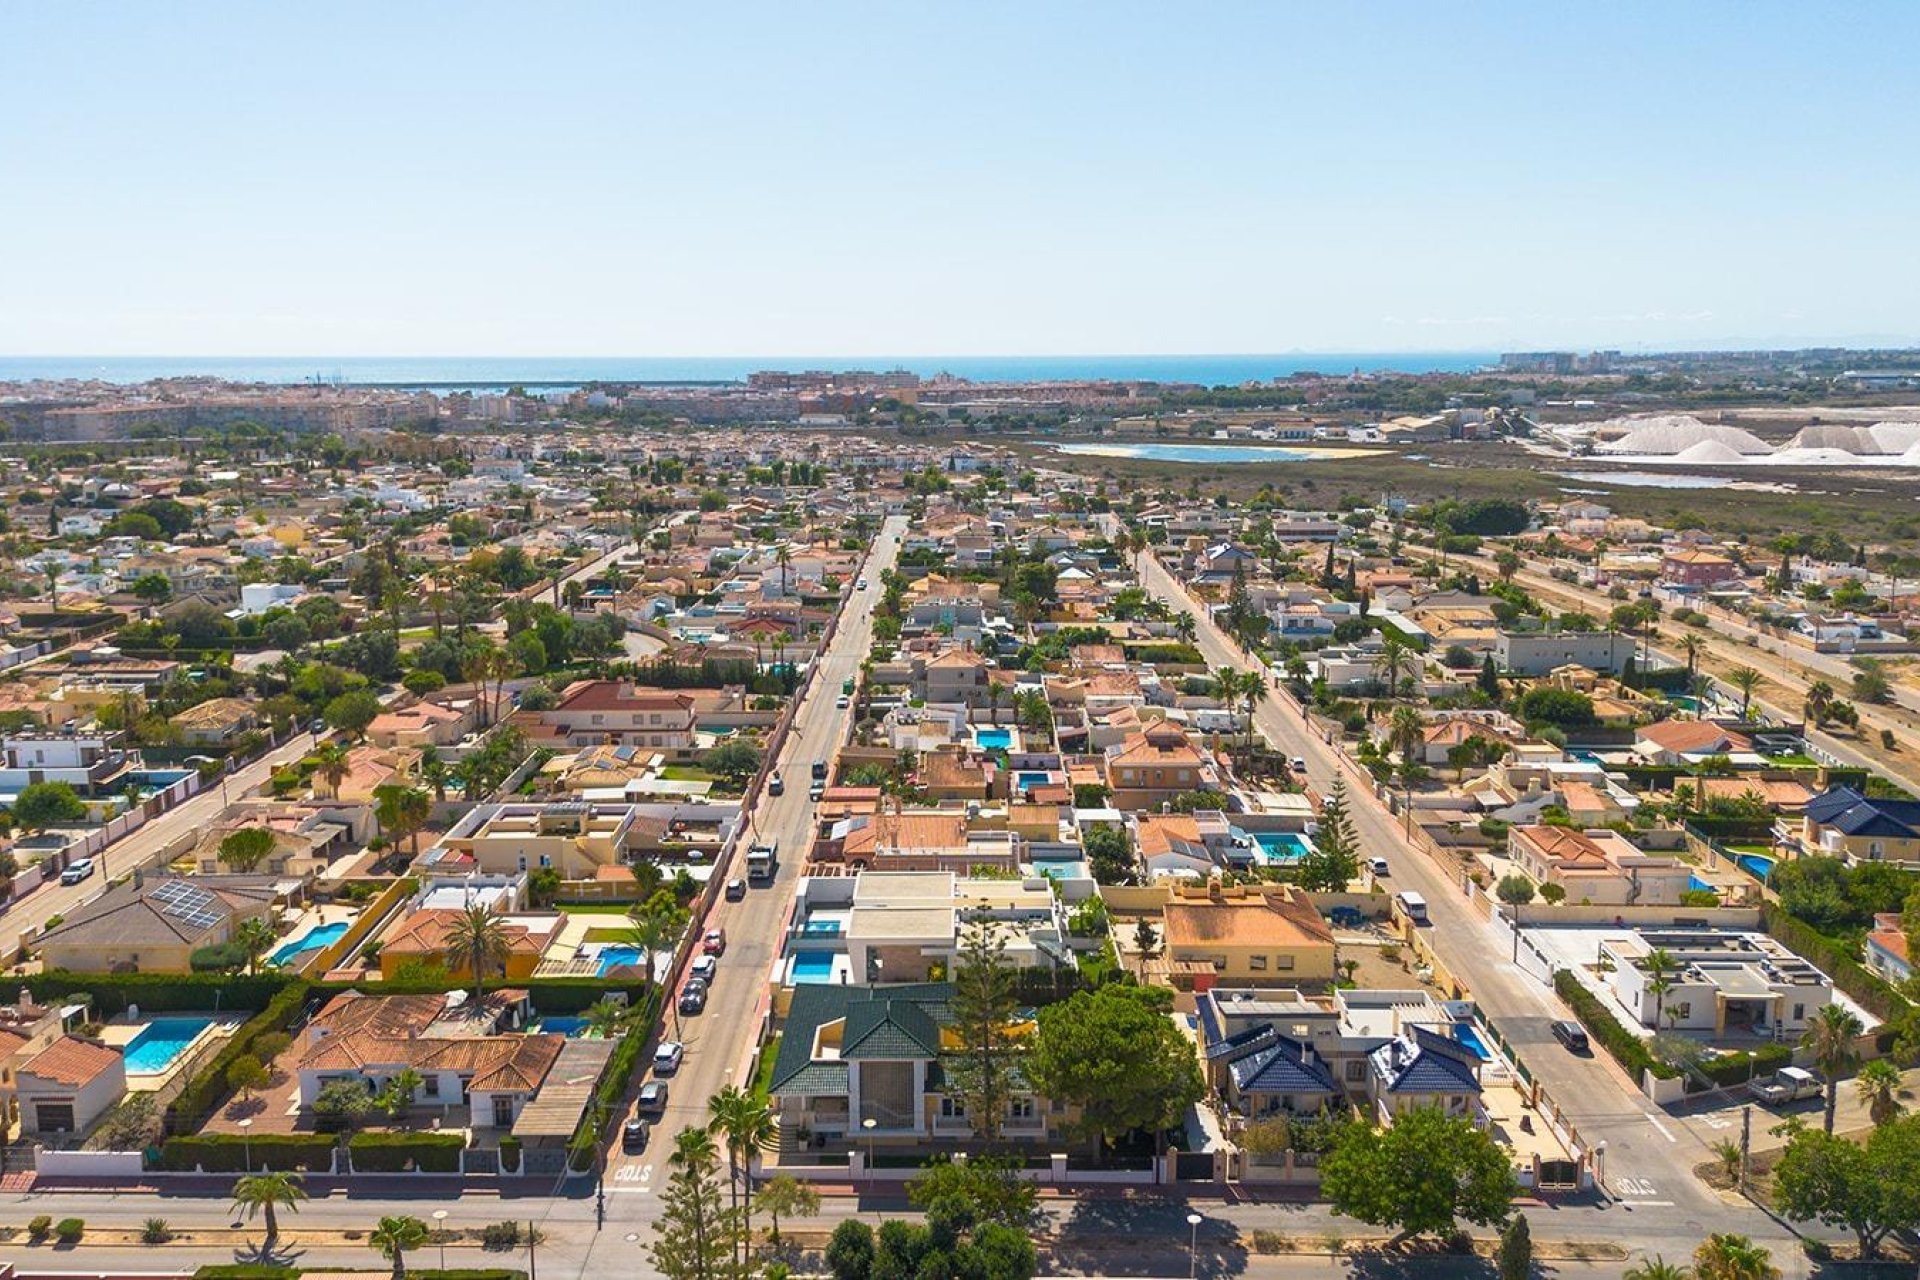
[1140,537,1764,1230]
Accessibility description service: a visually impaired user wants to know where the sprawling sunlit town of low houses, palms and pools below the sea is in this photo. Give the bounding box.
[0,351,1920,1280]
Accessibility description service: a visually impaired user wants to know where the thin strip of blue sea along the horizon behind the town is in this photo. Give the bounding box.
[0,351,1500,391]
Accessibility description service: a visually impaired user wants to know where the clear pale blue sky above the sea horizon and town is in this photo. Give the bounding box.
[0,0,1920,355]
